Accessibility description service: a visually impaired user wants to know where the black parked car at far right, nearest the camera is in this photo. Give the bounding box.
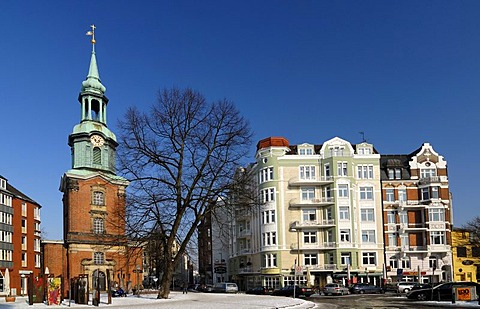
[407,281,480,301]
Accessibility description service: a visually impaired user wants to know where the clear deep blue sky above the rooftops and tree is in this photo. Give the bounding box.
[0,0,480,239]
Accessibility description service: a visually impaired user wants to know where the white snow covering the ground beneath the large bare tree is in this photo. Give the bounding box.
[0,291,315,309]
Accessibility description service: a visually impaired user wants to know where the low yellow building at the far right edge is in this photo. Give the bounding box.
[452,228,480,282]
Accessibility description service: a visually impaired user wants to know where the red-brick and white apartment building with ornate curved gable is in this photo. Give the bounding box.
[380,143,453,282]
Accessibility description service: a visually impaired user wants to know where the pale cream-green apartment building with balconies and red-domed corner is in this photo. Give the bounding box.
[231,137,384,289]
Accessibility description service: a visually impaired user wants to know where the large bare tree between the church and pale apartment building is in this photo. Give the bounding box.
[119,88,252,298]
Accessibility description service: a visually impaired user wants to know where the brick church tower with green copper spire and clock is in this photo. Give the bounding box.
[55,25,142,294]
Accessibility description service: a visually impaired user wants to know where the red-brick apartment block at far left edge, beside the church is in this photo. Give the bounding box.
[0,176,41,295]
